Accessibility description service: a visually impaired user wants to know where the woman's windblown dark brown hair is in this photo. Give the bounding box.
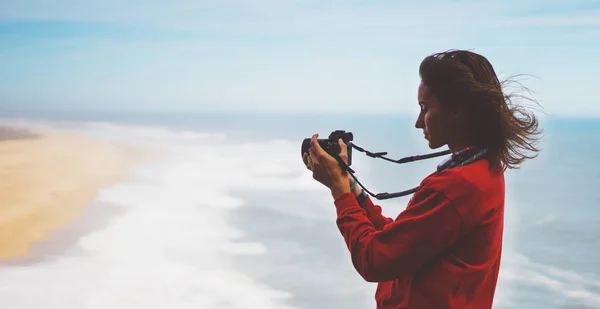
[419,50,542,171]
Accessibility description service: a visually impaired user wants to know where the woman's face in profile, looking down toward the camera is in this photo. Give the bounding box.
[415,82,464,151]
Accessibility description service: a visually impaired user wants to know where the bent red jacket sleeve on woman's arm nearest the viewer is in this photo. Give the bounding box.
[334,188,463,282]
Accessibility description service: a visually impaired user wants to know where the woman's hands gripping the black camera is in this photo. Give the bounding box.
[302,134,360,199]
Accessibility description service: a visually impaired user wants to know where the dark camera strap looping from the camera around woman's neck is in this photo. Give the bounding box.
[335,142,487,200]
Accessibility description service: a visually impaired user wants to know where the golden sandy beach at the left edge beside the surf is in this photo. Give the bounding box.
[0,126,142,262]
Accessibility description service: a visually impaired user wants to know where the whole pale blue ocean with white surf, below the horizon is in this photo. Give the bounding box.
[0,109,600,309]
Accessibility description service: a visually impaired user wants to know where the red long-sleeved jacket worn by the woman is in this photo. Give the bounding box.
[335,160,504,309]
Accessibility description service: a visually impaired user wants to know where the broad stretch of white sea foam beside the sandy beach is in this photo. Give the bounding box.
[0,124,314,309]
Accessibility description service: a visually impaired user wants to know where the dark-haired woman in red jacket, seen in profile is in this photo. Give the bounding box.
[305,50,540,309]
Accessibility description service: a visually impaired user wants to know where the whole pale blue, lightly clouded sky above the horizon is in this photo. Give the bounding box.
[0,0,600,117]
